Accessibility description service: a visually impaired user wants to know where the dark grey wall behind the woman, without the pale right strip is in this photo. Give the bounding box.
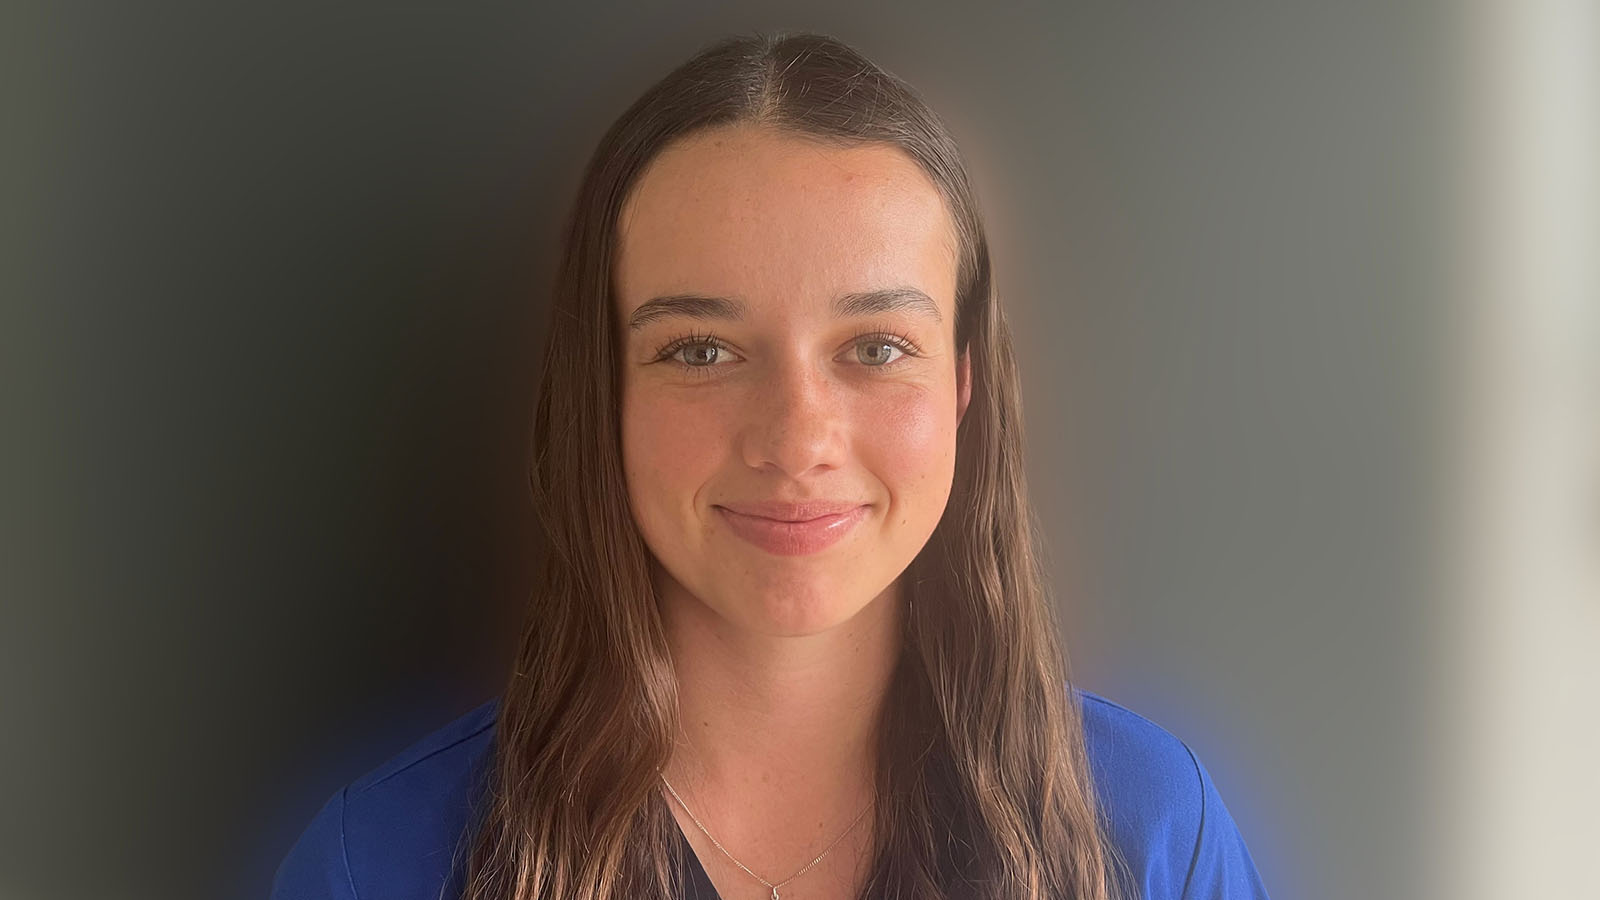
[0,0,1454,900]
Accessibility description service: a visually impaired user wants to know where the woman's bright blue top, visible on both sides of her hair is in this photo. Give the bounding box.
[272,689,1267,900]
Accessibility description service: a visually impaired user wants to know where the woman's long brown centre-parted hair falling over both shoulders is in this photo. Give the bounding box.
[466,34,1117,900]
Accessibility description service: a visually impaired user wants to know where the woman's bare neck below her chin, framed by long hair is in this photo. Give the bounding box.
[661,573,902,820]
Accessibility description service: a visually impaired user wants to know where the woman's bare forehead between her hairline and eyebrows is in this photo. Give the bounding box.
[616,127,955,320]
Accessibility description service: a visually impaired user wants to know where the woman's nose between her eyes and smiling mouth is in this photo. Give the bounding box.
[741,350,846,479]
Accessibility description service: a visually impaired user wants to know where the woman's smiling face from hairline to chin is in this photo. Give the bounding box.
[616,127,970,636]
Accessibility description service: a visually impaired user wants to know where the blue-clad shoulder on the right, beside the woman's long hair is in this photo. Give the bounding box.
[1074,689,1267,900]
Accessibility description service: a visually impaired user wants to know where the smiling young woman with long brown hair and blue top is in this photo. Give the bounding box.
[274,35,1266,900]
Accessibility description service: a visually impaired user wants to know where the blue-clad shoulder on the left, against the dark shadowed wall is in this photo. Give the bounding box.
[272,700,499,900]
